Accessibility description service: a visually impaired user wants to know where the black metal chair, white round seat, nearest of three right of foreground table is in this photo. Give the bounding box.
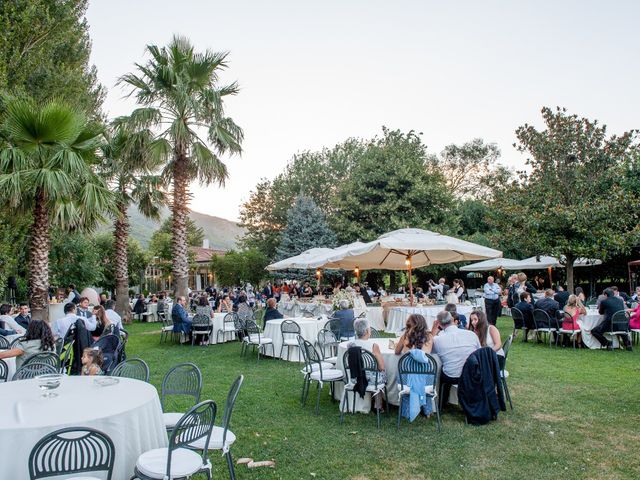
[131,400,217,480]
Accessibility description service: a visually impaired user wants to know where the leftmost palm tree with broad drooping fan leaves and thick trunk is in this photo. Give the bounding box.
[0,98,113,320]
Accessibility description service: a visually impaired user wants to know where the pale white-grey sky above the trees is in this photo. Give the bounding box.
[87,0,640,220]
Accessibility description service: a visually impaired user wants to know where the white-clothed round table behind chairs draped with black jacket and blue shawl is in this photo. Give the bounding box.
[333,338,440,413]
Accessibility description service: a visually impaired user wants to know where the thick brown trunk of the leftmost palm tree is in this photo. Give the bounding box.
[29,191,49,321]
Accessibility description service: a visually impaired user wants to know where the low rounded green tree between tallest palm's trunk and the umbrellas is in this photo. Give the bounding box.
[211,249,269,286]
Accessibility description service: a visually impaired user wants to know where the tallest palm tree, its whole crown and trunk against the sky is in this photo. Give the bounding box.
[120,36,244,296]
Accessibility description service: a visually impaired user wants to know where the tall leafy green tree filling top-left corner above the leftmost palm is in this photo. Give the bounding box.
[0,0,105,116]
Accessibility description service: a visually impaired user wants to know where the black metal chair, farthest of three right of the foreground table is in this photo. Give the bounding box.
[160,363,202,430]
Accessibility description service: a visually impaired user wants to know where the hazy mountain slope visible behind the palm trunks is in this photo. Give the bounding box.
[99,207,244,250]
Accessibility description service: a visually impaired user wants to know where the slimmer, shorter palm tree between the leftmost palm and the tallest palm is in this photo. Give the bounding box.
[102,117,165,321]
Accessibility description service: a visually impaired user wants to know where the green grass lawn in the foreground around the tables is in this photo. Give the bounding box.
[127,318,640,480]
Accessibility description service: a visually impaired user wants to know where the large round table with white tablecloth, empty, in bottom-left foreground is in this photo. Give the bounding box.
[0,376,167,479]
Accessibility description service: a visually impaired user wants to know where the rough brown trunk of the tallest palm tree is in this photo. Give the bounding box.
[171,149,189,297]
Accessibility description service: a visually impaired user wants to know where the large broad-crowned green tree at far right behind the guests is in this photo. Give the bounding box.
[492,107,640,290]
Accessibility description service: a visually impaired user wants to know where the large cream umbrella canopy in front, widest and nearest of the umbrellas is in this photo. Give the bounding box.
[323,228,502,270]
